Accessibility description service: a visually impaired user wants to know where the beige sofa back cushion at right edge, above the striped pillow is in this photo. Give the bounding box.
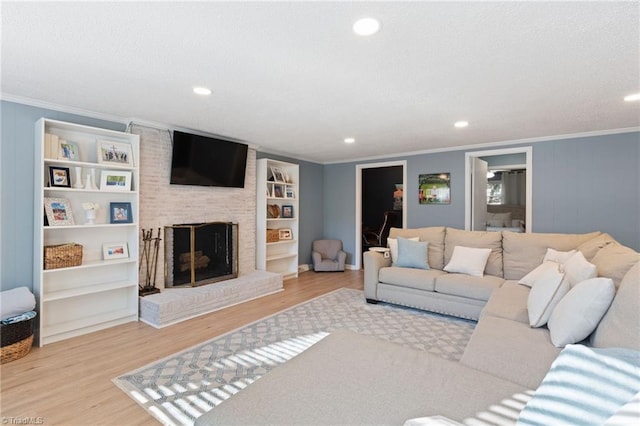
[591,262,640,351]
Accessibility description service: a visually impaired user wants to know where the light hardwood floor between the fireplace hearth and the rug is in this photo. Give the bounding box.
[0,271,363,425]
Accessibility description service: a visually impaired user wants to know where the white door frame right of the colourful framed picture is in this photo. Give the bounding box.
[464,146,533,232]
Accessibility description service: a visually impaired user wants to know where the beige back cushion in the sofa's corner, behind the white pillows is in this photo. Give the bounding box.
[502,232,601,280]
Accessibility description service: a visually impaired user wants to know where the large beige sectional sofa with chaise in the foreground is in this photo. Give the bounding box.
[196,227,640,425]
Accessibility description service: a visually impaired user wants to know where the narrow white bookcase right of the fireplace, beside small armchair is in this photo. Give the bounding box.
[256,158,300,279]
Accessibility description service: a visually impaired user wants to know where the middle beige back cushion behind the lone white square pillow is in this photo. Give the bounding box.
[444,228,504,277]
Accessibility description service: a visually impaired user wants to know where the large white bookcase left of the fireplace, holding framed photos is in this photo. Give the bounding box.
[33,119,139,346]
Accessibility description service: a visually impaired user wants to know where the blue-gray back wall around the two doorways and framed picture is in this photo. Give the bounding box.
[324,132,640,258]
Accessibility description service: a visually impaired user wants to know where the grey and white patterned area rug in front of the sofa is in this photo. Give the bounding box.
[113,288,476,425]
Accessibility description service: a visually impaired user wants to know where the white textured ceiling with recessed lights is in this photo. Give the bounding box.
[0,1,640,163]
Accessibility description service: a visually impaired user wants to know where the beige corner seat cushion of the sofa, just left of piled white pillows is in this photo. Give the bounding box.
[480,281,530,324]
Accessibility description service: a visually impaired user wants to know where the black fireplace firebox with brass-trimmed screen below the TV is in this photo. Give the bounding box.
[164,222,238,288]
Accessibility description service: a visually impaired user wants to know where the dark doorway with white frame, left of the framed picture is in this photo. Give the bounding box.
[354,161,407,269]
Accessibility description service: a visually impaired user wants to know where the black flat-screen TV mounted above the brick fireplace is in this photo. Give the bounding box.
[171,130,248,188]
